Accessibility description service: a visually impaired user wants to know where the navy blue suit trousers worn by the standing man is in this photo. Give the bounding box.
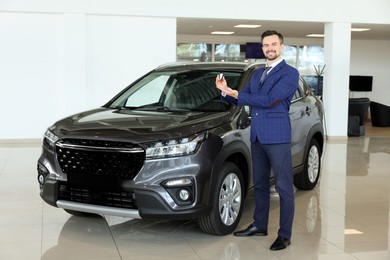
[251,140,295,239]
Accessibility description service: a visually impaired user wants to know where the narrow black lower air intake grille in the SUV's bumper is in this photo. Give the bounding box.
[58,183,137,209]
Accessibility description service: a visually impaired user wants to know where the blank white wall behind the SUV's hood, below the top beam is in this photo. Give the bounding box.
[0,12,176,139]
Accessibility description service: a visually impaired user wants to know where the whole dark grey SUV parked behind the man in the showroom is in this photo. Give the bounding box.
[38,62,324,235]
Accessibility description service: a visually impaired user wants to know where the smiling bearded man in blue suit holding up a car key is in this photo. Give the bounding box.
[216,31,299,250]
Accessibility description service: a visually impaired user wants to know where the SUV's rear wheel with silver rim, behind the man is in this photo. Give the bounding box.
[294,139,321,190]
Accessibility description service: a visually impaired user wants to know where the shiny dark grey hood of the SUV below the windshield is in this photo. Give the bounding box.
[51,108,229,143]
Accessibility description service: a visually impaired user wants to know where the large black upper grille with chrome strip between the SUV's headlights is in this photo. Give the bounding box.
[56,139,145,180]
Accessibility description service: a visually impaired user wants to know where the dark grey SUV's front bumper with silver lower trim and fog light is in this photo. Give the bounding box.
[38,146,213,219]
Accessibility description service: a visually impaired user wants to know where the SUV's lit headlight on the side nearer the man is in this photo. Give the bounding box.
[146,134,206,159]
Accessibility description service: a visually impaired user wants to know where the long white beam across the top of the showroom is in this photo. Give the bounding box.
[0,0,390,24]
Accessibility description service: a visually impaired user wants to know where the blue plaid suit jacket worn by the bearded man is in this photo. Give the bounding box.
[237,60,299,144]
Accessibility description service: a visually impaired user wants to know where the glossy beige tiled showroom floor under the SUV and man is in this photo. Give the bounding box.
[0,129,390,260]
